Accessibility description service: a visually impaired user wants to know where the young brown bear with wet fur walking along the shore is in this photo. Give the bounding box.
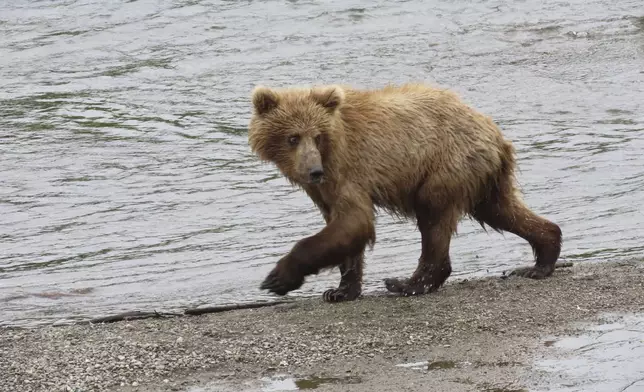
[248,84,562,302]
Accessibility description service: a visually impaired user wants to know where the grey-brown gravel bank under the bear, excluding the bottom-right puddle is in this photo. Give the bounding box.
[0,261,644,392]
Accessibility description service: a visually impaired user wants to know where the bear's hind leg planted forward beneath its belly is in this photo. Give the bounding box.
[385,208,458,296]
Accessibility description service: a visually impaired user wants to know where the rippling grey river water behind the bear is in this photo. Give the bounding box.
[0,0,644,325]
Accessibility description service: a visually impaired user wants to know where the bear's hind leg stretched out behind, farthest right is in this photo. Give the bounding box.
[473,182,562,279]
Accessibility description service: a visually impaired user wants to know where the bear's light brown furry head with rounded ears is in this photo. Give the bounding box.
[248,86,345,185]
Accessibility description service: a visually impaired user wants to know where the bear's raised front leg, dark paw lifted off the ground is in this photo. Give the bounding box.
[260,202,375,295]
